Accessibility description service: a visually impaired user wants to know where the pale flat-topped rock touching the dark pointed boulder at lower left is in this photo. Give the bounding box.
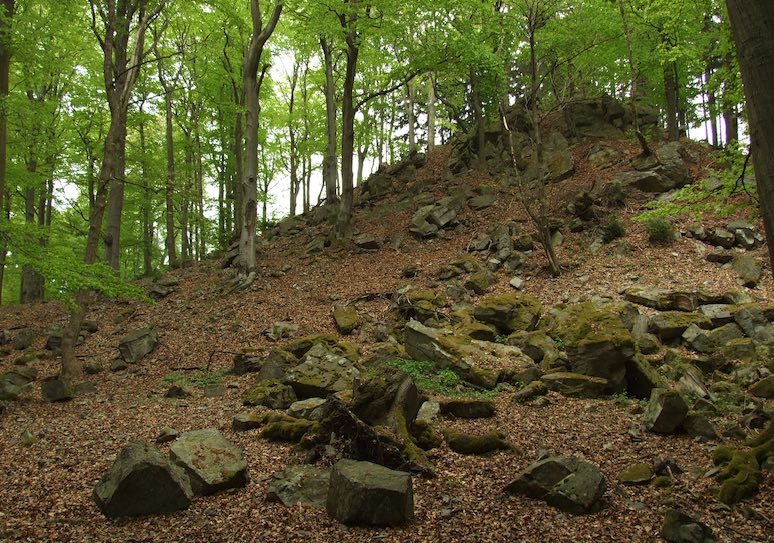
[169,428,248,495]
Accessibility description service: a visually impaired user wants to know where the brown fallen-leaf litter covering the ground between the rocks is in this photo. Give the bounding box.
[0,138,774,543]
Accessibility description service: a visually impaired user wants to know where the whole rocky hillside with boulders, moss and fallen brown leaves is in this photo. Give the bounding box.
[0,101,774,542]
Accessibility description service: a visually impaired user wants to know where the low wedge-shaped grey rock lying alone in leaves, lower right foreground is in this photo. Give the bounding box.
[505,456,606,515]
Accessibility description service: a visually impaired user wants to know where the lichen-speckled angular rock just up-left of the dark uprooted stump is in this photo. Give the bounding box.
[284,344,360,400]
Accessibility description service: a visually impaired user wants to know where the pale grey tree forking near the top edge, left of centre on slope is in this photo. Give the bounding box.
[238,0,284,280]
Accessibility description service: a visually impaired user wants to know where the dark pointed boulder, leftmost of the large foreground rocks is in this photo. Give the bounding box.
[93,442,193,518]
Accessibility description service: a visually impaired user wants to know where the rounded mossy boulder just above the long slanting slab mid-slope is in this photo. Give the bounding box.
[473,292,543,335]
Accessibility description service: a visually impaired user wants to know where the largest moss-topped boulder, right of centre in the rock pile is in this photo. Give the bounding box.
[546,302,636,393]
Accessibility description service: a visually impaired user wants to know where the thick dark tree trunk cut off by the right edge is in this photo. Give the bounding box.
[726,0,774,269]
